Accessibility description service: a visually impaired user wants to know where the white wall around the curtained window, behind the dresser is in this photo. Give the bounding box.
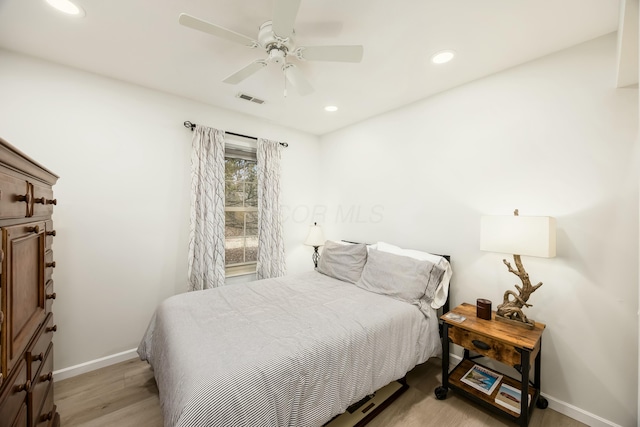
[0,50,319,369]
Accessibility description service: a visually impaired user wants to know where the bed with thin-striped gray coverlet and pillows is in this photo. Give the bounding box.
[138,242,451,427]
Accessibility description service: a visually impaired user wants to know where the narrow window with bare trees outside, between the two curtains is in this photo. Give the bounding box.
[224,145,258,276]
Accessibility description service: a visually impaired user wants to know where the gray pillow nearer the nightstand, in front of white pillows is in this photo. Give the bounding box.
[356,249,444,317]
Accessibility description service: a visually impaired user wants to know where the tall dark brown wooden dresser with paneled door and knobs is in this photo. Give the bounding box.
[0,138,60,427]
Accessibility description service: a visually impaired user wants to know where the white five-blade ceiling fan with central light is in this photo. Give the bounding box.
[178,0,364,95]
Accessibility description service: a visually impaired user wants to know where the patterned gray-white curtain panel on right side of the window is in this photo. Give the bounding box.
[256,138,286,279]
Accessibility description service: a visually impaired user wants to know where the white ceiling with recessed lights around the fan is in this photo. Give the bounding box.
[0,0,637,135]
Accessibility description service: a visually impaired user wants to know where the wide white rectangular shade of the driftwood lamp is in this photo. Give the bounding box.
[480,215,556,258]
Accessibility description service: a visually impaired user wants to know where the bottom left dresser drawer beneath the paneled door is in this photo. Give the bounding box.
[0,360,31,427]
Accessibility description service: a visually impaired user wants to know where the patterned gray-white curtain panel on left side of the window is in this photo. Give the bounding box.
[188,125,225,291]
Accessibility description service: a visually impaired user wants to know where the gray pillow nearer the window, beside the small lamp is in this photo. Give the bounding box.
[318,240,367,283]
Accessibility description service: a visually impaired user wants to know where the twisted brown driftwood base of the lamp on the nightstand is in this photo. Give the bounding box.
[496,209,542,329]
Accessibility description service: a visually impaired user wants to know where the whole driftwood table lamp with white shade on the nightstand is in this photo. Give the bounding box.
[480,209,556,329]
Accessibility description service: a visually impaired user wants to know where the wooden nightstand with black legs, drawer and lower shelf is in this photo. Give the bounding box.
[435,303,547,426]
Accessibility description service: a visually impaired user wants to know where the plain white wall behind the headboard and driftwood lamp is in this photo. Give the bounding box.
[321,35,638,426]
